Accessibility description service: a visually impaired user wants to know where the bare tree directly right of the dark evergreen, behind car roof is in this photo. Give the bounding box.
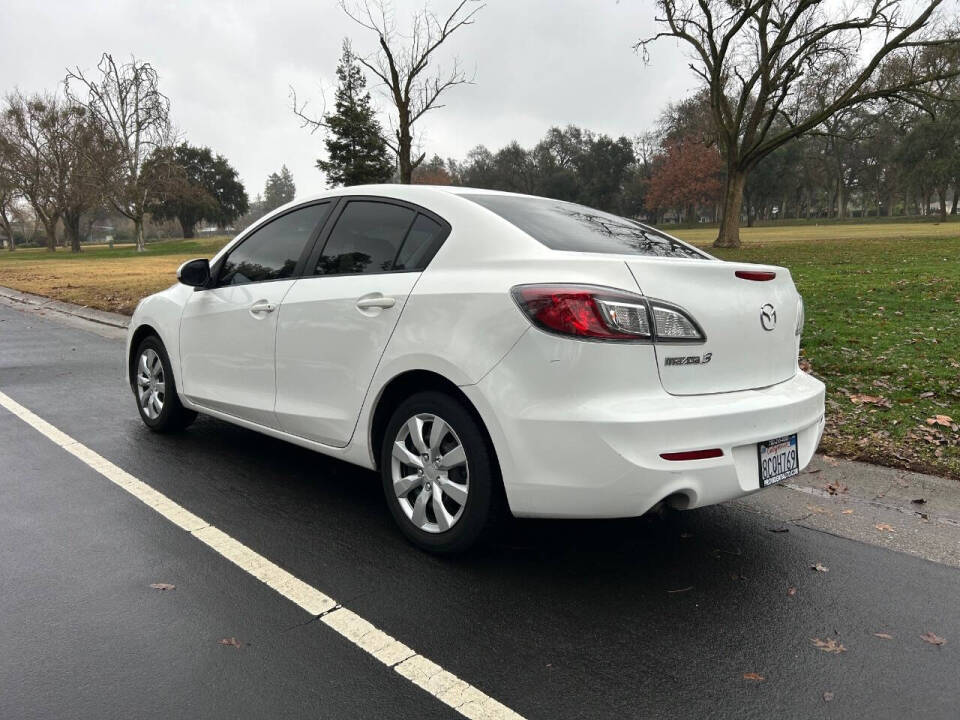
[293,0,484,184]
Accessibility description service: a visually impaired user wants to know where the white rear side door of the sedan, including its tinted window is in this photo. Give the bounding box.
[276,198,450,447]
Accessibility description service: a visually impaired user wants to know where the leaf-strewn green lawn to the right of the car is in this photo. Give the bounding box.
[678,231,960,478]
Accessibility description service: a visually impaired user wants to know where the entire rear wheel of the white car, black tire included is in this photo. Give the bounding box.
[380,391,503,555]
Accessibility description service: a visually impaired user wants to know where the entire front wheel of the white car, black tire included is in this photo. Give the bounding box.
[132,335,197,433]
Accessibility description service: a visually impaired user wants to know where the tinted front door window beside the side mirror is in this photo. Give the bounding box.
[217,203,330,285]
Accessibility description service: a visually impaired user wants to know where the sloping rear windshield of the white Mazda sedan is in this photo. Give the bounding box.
[461,195,710,260]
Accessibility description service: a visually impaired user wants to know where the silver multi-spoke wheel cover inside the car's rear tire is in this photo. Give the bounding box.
[391,413,470,533]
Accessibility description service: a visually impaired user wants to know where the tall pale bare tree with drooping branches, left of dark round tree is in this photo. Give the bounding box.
[64,53,173,251]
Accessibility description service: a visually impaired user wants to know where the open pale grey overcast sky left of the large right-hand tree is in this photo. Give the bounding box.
[0,0,693,197]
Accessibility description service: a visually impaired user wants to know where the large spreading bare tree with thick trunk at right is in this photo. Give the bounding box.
[635,0,960,247]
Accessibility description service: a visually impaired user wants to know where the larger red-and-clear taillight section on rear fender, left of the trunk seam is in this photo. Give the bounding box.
[512,285,650,340]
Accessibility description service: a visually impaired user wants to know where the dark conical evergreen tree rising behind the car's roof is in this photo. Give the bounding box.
[317,40,393,187]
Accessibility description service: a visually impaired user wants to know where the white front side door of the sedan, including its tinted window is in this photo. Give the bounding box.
[180,202,332,428]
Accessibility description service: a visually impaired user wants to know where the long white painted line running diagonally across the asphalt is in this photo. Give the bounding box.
[0,392,523,720]
